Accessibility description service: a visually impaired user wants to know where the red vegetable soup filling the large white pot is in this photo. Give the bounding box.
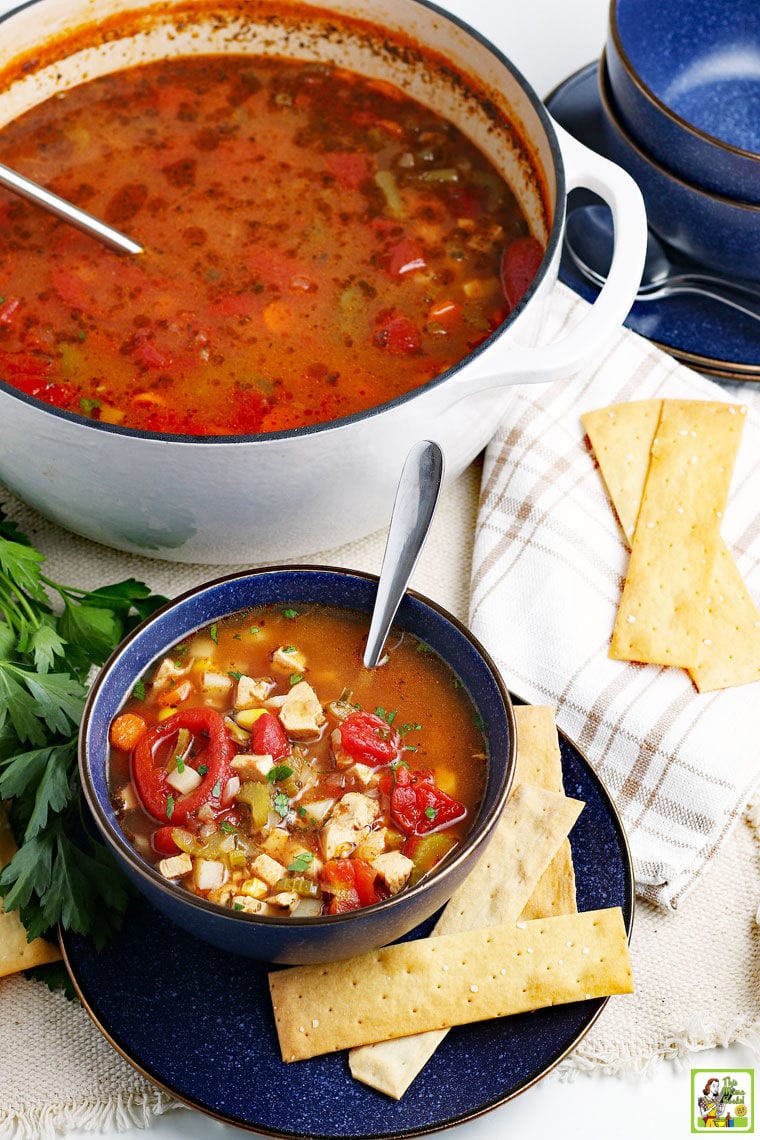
[0,55,541,435]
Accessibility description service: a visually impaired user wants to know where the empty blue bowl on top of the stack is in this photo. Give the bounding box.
[606,0,760,203]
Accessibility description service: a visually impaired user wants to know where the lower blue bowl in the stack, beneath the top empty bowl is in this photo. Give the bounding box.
[599,55,760,280]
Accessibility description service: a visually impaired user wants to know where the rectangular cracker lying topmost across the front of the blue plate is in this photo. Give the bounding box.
[269,907,634,1061]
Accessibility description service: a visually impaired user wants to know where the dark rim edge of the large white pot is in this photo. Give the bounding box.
[0,0,566,447]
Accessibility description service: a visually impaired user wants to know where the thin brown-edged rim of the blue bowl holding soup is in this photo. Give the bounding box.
[77,563,517,931]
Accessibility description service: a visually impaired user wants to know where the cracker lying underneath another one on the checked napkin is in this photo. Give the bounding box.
[581,400,760,692]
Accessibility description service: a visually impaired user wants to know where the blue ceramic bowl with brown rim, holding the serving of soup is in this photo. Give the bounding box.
[80,567,516,963]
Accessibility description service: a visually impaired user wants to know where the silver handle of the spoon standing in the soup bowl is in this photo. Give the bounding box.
[363,440,443,669]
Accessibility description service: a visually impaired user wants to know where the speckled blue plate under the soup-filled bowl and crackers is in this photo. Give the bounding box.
[62,720,634,1140]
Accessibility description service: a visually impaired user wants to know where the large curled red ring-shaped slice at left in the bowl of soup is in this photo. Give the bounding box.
[131,707,235,827]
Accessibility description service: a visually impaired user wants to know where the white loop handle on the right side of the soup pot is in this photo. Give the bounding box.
[471,120,647,391]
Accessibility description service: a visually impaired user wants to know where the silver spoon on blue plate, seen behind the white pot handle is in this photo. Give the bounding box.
[565,205,760,320]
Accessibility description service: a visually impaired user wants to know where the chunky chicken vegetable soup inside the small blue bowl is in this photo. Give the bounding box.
[108,604,488,915]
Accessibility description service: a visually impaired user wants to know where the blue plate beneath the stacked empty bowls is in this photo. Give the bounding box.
[546,64,760,381]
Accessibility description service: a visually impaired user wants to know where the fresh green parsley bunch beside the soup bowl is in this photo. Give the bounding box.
[0,510,165,946]
